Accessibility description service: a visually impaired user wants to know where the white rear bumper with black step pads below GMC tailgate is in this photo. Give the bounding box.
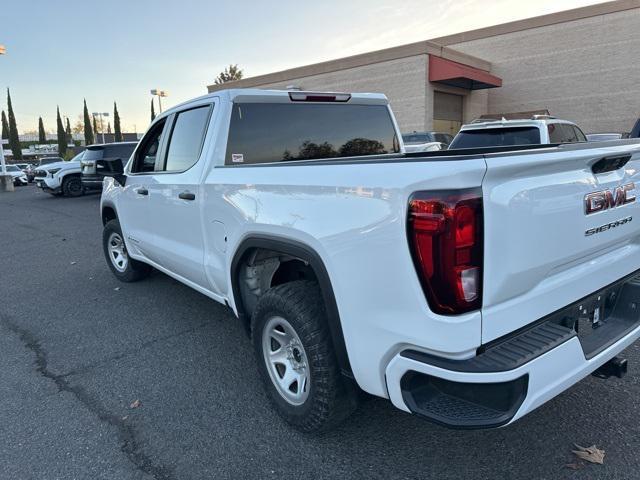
[385,274,640,428]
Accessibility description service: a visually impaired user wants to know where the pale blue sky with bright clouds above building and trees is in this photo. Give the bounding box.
[0,0,600,133]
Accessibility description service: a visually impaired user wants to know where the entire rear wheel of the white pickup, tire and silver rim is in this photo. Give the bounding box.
[252,280,356,432]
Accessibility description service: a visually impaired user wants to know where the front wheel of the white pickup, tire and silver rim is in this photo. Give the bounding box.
[102,220,151,282]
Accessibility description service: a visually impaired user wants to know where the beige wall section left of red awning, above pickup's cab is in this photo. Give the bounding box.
[230,55,430,131]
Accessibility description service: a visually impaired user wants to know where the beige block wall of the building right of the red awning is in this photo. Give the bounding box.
[448,8,640,132]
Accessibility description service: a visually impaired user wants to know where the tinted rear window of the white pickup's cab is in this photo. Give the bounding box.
[225,103,400,165]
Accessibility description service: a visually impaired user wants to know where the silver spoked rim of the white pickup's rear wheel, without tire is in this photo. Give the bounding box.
[262,316,311,406]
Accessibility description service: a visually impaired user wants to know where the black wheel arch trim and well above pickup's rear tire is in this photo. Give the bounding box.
[231,235,353,378]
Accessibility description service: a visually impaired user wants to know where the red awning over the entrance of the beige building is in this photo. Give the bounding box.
[429,55,502,90]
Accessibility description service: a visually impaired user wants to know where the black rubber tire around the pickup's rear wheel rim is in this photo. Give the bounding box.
[251,280,357,432]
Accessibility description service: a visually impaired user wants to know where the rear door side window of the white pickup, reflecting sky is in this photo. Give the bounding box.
[164,105,211,172]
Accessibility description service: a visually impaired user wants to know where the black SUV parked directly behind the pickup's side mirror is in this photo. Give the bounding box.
[80,142,138,191]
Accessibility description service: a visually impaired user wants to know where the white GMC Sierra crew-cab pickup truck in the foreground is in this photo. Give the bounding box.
[101,90,640,431]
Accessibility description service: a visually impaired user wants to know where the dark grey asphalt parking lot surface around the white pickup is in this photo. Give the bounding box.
[0,186,640,479]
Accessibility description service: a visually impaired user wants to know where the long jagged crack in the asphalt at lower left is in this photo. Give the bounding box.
[0,318,174,480]
